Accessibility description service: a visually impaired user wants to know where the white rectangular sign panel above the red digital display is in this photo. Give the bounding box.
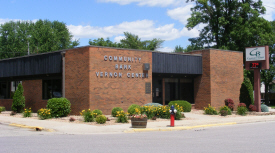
[245,47,265,61]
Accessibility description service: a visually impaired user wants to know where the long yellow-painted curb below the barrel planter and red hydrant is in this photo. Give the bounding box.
[124,122,237,133]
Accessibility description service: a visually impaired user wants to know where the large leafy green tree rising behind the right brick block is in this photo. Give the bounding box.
[186,0,274,51]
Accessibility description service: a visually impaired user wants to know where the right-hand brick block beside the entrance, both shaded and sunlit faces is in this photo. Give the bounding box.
[188,49,243,109]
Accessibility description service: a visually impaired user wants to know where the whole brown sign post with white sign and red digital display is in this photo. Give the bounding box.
[245,46,269,112]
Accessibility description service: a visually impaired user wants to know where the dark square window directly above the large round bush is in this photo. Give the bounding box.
[42,79,62,99]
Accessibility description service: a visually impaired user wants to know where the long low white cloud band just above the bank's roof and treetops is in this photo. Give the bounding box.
[68,20,201,42]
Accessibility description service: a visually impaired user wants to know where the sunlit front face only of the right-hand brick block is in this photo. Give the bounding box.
[210,50,243,108]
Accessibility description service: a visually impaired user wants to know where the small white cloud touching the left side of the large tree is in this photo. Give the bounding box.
[167,4,194,25]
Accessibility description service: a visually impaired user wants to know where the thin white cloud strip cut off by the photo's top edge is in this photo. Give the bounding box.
[98,0,185,7]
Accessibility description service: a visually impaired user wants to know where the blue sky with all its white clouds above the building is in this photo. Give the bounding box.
[0,0,275,52]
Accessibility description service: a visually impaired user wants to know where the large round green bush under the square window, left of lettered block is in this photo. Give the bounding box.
[47,98,71,117]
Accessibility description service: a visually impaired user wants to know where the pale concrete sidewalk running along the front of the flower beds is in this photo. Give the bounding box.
[0,110,275,134]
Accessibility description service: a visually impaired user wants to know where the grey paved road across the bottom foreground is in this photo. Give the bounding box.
[0,122,275,153]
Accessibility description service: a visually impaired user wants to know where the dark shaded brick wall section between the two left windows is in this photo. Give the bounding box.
[22,80,47,112]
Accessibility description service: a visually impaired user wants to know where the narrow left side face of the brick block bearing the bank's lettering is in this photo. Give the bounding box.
[65,47,90,115]
